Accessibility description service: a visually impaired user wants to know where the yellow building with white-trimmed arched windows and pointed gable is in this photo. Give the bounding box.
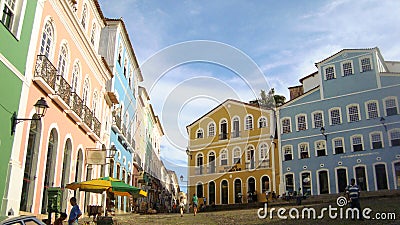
[186,99,279,205]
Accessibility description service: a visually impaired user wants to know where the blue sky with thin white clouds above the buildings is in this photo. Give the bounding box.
[99,0,400,190]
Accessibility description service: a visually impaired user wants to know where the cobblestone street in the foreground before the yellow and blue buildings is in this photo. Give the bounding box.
[79,196,400,225]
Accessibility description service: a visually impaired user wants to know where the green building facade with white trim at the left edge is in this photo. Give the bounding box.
[0,0,40,216]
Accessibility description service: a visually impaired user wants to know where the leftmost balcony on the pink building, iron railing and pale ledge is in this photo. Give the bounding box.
[33,55,57,94]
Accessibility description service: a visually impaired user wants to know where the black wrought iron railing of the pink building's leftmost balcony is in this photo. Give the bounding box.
[35,55,57,90]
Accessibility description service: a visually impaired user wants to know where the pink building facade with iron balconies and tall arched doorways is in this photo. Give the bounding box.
[6,0,112,214]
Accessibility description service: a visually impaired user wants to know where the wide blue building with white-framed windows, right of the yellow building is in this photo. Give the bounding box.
[278,48,400,195]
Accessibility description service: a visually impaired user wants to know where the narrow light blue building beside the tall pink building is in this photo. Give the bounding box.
[100,19,143,211]
